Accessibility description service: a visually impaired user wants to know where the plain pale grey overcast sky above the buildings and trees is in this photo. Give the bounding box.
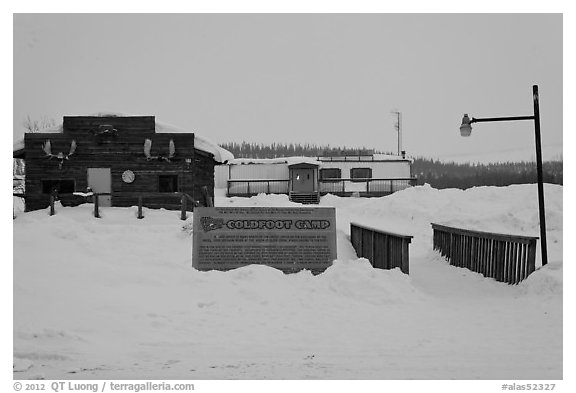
[14,14,563,161]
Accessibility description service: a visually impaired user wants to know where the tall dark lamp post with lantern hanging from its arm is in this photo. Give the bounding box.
[460,85,548,266]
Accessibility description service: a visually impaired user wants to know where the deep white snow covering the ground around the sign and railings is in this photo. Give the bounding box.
[13,185,563,380]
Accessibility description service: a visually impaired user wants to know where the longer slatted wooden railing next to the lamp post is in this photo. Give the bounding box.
[432,224,538,284]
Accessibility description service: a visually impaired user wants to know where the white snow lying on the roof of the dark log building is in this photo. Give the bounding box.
[13,112,234,163]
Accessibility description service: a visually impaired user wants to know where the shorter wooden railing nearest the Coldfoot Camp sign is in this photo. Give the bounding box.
[350,223,412,274]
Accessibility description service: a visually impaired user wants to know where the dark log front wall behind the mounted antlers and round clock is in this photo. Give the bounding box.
[24,116,214,211]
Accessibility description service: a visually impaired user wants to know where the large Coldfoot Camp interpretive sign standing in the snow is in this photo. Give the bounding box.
[192,207,336,273]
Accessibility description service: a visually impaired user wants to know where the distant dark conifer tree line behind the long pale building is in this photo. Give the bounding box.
[220,142,563,189]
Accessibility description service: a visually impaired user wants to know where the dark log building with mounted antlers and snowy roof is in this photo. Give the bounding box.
[14,114,233,211]
